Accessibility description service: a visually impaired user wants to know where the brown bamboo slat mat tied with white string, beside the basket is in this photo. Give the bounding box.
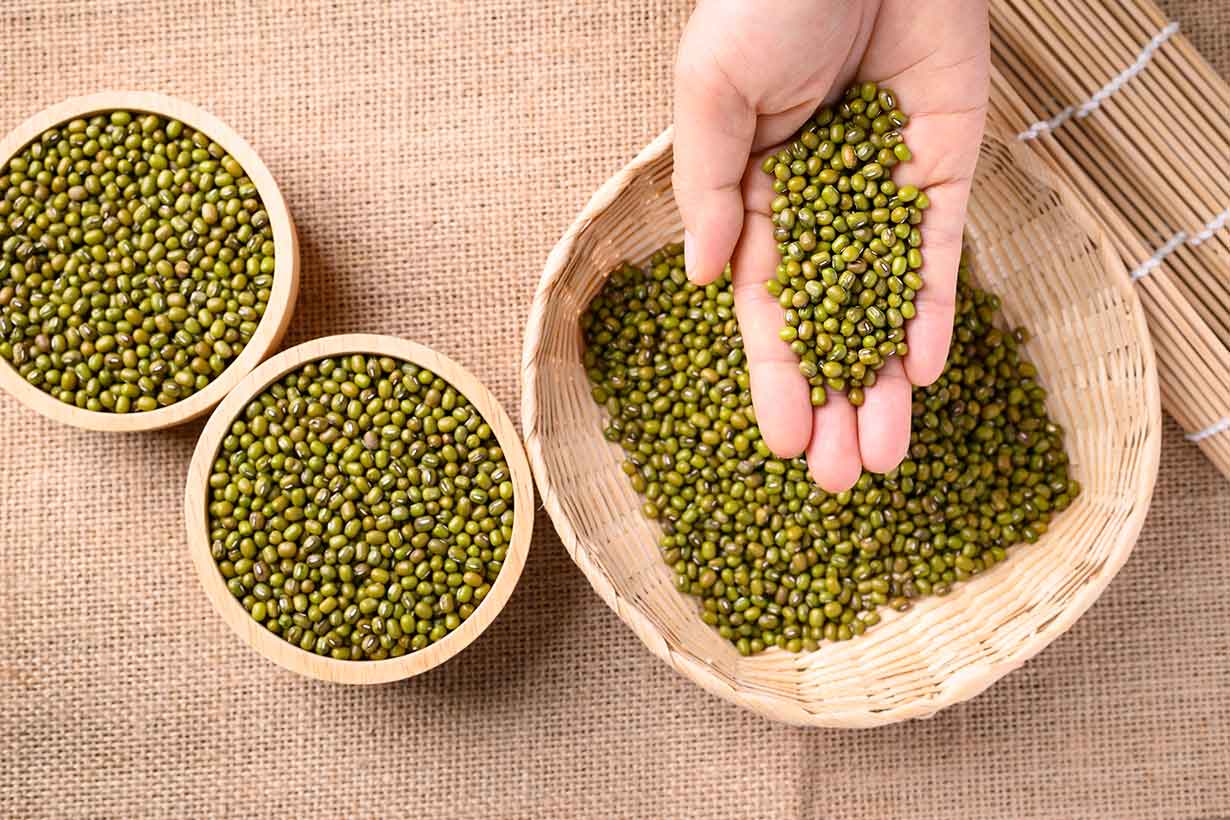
[991,0,1230,477]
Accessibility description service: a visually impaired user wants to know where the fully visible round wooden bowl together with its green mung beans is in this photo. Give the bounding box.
[185,334,534,684]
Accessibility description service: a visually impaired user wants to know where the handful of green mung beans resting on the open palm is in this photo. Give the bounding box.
[763,82,930,406]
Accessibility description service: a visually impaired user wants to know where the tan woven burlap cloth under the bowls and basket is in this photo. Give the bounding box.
[0,0,1230,819]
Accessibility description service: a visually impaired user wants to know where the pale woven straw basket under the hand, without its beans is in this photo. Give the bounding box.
[523,112,1161,727]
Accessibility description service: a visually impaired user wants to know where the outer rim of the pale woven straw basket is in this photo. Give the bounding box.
[522,123,1161,728]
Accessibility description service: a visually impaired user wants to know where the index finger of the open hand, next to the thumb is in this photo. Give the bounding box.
[731,199,812,459]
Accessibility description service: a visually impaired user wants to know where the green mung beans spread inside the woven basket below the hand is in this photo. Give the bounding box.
[582,245,1080,654]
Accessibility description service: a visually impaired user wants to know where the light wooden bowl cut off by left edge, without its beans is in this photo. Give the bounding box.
[0,91,299,433]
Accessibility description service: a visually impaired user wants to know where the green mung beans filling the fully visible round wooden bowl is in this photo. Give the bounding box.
[208,354,513,660]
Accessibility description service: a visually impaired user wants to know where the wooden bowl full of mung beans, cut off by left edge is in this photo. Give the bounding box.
[0,91,299,432]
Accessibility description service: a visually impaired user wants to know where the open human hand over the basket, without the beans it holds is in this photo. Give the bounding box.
[673,0,990,492]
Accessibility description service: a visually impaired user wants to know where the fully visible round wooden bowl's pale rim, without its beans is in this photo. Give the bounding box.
[185,333,534,684]
